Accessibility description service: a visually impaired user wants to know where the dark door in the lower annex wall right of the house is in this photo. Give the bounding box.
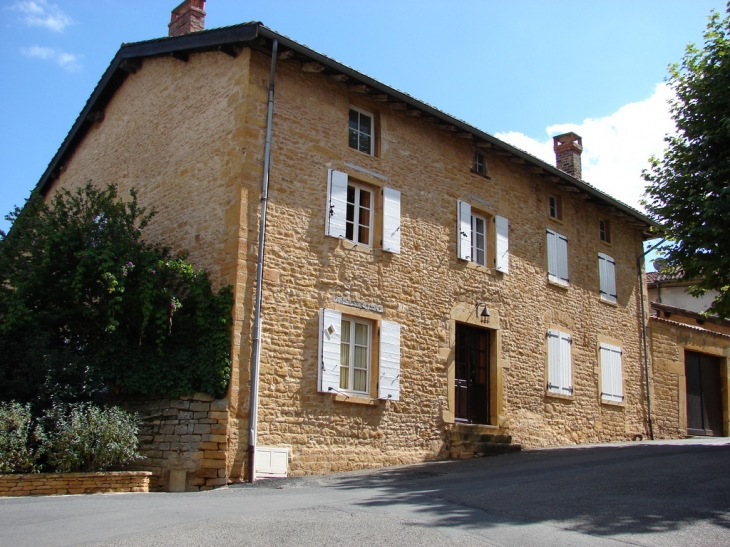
[684,351,722,437]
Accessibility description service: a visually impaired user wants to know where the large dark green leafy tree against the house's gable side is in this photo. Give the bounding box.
[0,183,232,413]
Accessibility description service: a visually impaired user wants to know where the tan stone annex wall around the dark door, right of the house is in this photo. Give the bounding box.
[649,314,730,438]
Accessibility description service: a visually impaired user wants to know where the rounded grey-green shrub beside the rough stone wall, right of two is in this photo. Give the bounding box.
[45,403,140,473]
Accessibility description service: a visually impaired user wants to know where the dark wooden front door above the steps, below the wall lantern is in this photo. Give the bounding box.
[454,324,490,424]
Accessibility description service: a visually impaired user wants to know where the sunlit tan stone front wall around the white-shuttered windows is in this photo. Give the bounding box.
[226,49,646,475]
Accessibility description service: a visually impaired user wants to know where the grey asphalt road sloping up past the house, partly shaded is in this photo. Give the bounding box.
[0,439,730,547]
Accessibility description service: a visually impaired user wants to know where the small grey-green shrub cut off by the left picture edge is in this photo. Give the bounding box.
[0,401,45,473]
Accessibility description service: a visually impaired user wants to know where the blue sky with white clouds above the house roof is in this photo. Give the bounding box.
[0,0,725,266]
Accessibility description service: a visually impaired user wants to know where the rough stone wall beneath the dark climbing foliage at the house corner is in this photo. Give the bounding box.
[120,393,228,492]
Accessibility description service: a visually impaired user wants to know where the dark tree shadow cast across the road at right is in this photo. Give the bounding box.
[324,445,730,536]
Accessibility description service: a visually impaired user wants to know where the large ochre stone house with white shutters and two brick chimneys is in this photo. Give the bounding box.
[38,0,681,489]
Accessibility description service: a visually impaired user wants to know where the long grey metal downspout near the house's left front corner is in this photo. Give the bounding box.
[248,39,279,482]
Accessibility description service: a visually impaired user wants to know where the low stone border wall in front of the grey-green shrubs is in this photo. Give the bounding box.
[0,471,152,496]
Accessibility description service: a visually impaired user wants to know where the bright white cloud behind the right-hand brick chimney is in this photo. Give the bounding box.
[495,84,675,209]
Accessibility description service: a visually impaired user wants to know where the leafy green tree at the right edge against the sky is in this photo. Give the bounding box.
[644,3,730,317]
